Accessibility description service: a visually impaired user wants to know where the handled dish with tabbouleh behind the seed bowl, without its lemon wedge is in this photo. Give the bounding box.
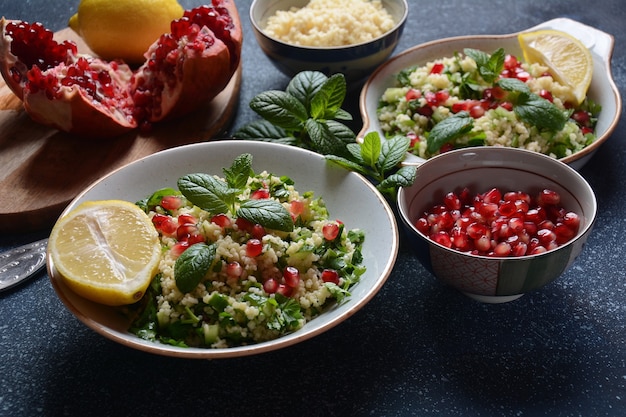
[357,18,622,169]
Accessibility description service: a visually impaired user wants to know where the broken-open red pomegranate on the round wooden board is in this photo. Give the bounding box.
[0,0,242,137]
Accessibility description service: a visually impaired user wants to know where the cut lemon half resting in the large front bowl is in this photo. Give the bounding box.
[48,200,161,306]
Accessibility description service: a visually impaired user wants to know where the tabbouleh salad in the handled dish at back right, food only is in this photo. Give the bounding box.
[378,48,600,159]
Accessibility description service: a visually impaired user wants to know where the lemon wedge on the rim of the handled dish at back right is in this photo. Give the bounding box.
[517,29,593,105]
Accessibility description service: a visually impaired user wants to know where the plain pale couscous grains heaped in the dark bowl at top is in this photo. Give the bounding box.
[264,0,395,47]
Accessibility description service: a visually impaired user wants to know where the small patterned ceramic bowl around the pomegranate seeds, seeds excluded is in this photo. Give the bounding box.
[397,146,597,303]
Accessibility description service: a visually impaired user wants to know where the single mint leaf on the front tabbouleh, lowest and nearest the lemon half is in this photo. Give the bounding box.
[174,243,217,293]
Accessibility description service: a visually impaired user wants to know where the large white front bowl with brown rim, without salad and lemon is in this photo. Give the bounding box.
[47,140,398,359]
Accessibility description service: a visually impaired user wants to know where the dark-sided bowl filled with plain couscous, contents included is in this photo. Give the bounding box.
[250,0,408,84]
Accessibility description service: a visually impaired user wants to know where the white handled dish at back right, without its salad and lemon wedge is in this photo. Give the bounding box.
[357,18,622,169]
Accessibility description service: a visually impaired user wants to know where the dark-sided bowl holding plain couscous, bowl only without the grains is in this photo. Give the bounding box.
[250,0,409,84]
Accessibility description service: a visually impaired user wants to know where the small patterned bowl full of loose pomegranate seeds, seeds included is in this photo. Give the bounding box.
[397,147,597,303]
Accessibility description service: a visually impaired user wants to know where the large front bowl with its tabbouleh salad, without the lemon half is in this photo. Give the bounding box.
[48,140,399,359]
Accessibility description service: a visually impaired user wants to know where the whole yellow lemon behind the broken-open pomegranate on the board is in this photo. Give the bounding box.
[69,0,184,64]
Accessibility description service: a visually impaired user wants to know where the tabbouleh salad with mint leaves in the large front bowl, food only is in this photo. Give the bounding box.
[130,154,365,348]
